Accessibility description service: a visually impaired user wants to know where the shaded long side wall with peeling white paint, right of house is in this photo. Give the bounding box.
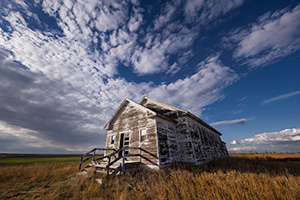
[156,112,228,165]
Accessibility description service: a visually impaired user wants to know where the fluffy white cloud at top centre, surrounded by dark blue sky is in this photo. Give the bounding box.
[131,24,196,75]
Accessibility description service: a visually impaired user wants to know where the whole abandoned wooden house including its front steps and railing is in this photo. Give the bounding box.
[78,97,228,175]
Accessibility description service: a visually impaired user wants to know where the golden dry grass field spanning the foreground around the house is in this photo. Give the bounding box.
[0,153,300,200]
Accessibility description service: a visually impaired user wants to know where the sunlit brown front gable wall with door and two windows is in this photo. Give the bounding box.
[106,102,158,164]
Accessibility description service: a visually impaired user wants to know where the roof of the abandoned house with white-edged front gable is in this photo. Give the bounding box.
[104,97,222,135]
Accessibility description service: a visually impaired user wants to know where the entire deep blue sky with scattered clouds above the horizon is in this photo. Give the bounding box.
[0,0,300,153]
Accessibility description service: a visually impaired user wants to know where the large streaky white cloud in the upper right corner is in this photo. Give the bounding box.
[225,4,300,67]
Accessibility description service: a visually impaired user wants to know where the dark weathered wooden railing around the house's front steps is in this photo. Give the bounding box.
[79,147,158,177]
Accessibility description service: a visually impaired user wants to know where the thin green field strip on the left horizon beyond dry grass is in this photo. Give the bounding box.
[0,154,80,167]
